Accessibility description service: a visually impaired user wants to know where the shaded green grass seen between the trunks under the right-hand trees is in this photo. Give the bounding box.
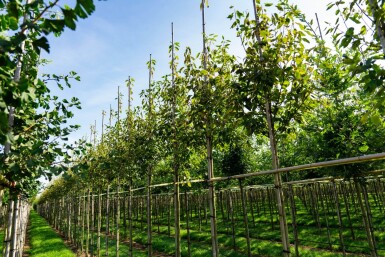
[38,184,385,257]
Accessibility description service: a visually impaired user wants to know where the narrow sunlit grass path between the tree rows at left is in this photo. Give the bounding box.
[28,211,75,257]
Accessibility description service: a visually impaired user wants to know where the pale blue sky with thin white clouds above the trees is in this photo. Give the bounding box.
[40,0,330,141]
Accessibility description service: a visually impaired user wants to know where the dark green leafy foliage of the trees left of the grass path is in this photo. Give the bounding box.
[0,0,95,195]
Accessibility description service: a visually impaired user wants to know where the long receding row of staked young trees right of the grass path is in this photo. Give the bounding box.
[39,0,385,256]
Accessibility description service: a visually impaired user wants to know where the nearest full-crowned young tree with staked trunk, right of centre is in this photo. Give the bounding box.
[230,0,312,256]
